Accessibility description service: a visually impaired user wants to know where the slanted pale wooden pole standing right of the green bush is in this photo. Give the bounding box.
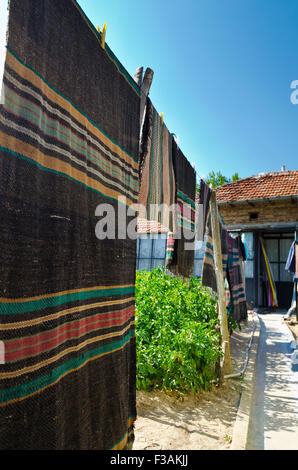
[210,191,232,375]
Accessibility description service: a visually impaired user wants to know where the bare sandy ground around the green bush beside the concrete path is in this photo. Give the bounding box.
[133,313,254,450]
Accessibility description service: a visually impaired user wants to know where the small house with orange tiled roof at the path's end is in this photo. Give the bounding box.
[216,167,298,309]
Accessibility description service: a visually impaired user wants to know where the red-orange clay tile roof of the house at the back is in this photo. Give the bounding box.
[216,170,298,202]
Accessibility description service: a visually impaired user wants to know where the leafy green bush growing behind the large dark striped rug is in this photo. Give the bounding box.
[136,268,226,393]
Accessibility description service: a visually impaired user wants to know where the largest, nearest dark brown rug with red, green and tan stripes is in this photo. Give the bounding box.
[0,0,140,450]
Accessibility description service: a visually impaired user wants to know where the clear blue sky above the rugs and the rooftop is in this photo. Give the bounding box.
[79,0,298,182]
